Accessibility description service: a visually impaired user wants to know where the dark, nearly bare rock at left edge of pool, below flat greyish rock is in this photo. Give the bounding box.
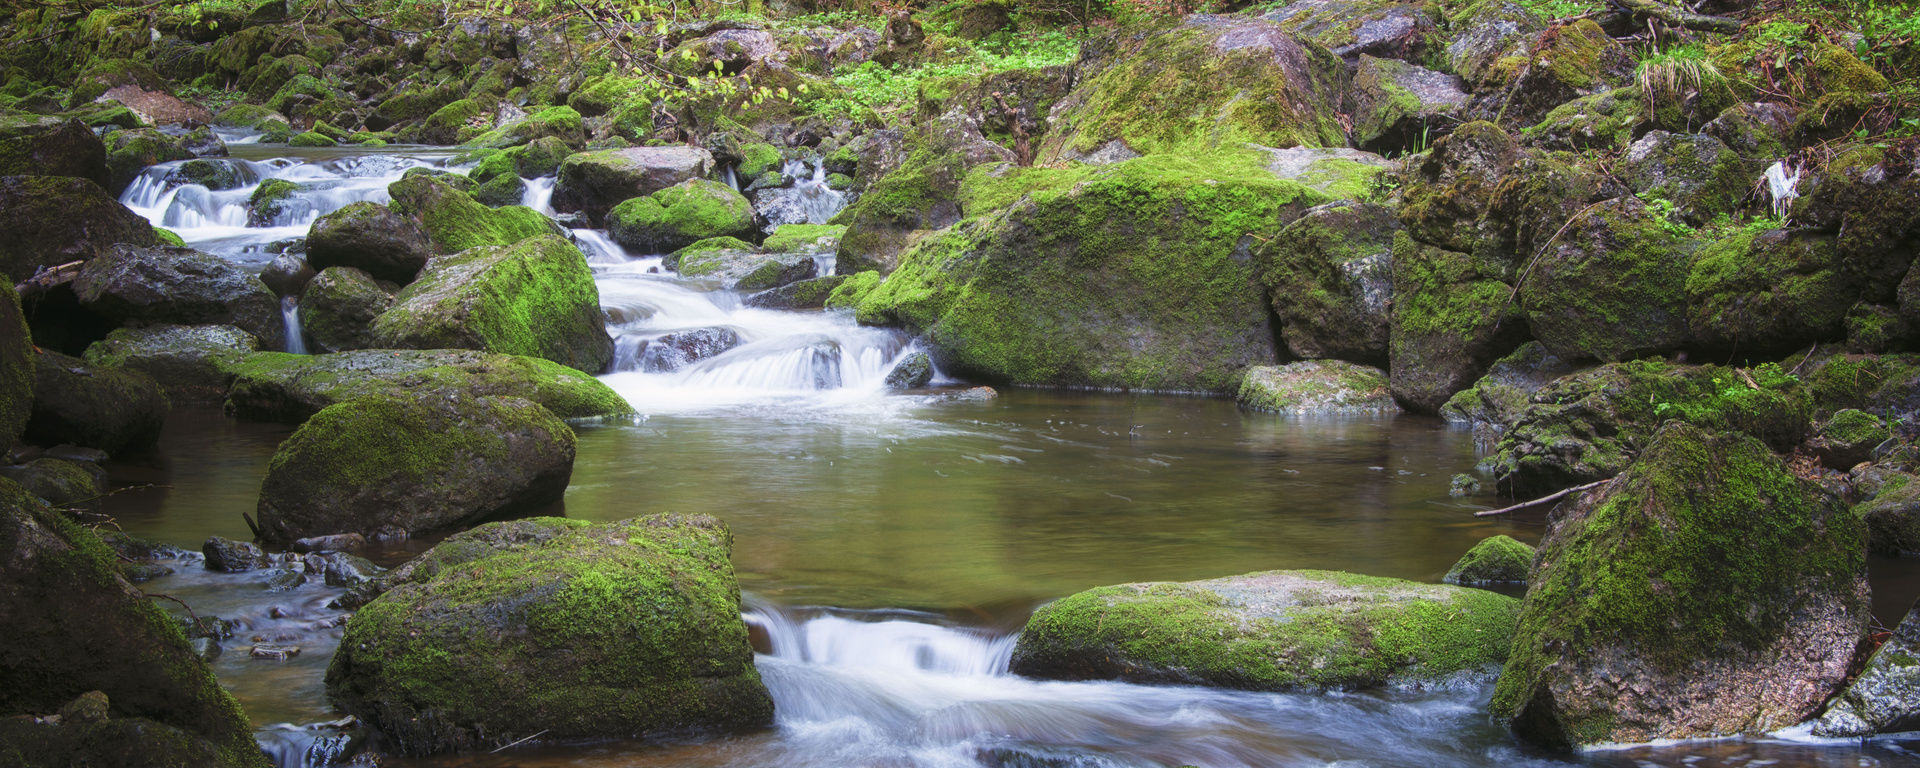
[25,349,167,453]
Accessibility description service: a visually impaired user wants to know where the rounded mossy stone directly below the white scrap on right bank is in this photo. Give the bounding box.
[1686,228,1864,355]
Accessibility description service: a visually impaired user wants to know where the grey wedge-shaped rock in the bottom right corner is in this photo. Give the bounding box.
[1812,607,1920,739]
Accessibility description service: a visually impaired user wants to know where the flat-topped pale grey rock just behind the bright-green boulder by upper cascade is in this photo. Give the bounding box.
[553,146,714,223]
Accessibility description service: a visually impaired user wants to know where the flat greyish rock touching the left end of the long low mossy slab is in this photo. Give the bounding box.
[86,324,261,403]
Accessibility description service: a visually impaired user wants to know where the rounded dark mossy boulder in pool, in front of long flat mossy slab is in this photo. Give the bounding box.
[259,394,574,543]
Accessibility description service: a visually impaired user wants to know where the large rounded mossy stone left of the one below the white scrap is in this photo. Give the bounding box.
[1519,198,1693,361]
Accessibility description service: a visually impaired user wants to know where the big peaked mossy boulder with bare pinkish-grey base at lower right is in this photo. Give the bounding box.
[1492,424,1870,749]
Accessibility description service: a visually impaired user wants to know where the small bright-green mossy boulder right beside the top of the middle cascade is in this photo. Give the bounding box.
[607,179,753,252]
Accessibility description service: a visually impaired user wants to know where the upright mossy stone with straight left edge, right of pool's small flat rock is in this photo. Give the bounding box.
[1388,232,1526,413]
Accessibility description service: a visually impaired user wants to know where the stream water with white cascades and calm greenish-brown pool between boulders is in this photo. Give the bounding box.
[93,144,1920,768]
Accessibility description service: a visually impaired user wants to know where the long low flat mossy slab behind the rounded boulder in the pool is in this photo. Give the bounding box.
[227,349,634,424]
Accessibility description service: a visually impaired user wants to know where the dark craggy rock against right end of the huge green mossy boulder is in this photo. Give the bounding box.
[1252,202,1402,367]
